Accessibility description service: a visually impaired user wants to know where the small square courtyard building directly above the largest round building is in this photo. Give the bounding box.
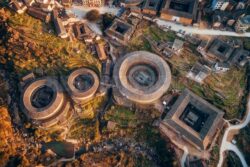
[105,18,135,44]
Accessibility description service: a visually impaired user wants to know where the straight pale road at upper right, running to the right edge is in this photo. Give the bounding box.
[153,18,250,37]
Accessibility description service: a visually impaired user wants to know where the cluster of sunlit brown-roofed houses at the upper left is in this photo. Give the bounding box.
[9,0,102,43]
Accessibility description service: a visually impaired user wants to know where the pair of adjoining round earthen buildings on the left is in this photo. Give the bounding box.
[20,68,99,129]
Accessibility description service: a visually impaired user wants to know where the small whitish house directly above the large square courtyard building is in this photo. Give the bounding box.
[187,63,210,84]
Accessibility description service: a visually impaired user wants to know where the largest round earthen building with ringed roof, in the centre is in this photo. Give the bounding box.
[113,51,171,104]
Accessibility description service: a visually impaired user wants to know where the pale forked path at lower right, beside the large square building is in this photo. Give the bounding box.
[217,94,250,167]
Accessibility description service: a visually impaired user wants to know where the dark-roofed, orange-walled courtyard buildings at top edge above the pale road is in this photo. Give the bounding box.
[122,0,199,25]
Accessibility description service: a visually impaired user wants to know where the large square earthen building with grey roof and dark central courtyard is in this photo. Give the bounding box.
[159,89,224,150]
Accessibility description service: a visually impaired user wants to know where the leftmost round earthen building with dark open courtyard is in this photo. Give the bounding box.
[22,77,73,128]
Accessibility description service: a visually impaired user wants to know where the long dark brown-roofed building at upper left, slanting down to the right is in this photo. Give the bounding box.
[27,7,51,23]
